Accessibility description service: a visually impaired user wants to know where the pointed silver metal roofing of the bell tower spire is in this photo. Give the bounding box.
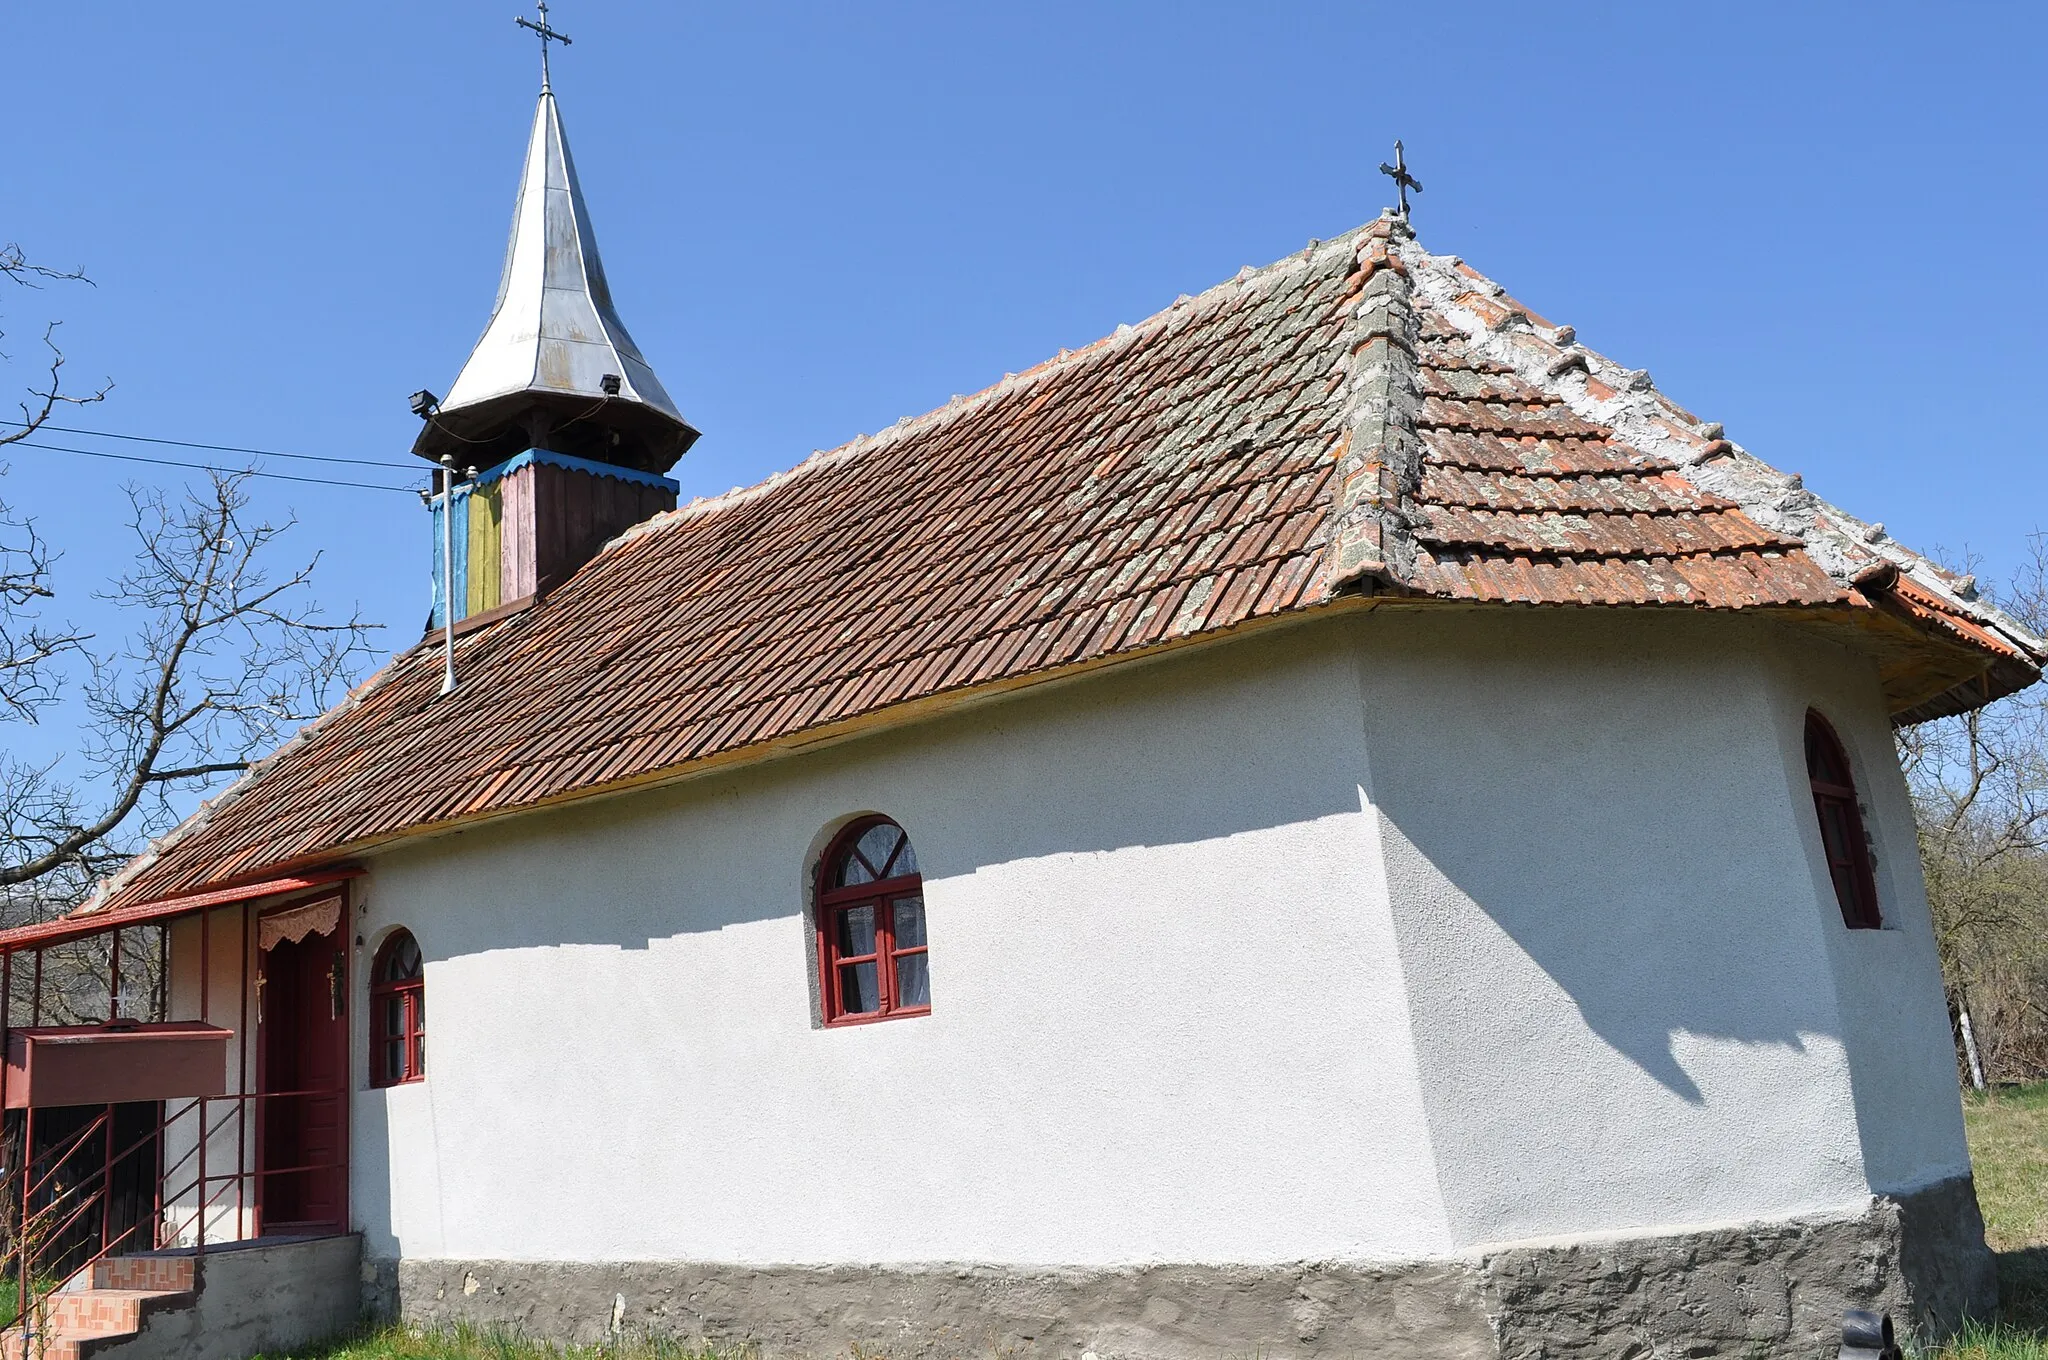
[414,88,696,471]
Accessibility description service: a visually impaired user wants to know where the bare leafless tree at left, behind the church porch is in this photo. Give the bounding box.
[0,246,371,924]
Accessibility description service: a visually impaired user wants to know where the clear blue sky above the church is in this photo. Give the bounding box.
[0,0,2048,739]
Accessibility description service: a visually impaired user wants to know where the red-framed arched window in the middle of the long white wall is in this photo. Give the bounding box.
[817,817,932,1024]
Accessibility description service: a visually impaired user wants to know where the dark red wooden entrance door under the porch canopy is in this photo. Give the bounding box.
[256,930,348,1235]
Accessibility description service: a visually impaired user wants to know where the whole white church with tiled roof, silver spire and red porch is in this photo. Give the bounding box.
[0,42,2048,1360]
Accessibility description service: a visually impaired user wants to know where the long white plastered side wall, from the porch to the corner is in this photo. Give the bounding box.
[354,629,1448,1264]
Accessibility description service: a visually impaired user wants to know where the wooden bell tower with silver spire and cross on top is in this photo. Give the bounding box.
[412,4,696,627]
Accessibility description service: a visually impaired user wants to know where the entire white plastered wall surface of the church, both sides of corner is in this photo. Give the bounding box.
[352,610,1966,1266]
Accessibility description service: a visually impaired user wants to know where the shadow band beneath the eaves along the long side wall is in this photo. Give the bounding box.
[377,629,1364,961]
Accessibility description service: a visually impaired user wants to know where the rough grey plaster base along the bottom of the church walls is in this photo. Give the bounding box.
[365,1178,1997,1360]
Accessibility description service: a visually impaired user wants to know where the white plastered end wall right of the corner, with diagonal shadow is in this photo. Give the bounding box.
[1360,610,1968,1247]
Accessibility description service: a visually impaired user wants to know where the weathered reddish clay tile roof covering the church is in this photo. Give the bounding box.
[88,217,2044,909]
